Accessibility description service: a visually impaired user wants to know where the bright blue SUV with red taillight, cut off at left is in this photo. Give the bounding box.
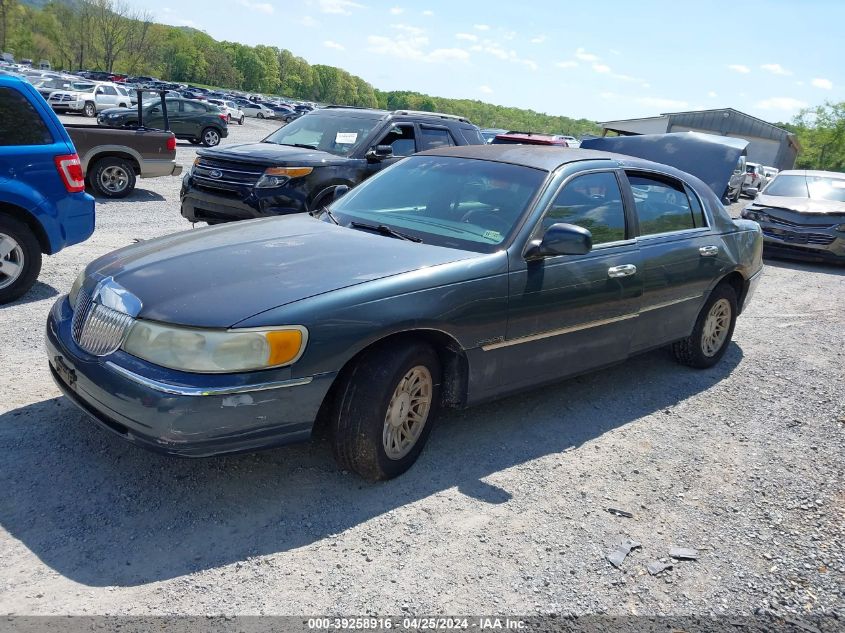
[0,76,94,303]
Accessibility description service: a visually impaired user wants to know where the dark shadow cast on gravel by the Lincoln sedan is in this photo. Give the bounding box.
[0,343,742,586]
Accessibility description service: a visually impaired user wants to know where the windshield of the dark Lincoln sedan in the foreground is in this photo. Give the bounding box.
[330,156,547,253]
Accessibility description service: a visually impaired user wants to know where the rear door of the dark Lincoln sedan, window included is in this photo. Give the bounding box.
[626,170,726,352]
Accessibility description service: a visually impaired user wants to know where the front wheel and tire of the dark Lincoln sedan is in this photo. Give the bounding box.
[330,342,440,481]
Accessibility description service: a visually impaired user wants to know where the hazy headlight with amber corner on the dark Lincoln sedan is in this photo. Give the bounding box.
[123,320,308,373]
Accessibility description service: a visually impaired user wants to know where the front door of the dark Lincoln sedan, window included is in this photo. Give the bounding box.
[498,170,642,388]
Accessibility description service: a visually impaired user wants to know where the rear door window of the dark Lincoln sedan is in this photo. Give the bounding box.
[628,173,706,235]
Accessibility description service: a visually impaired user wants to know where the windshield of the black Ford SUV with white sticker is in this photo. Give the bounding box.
[264,112,381,156]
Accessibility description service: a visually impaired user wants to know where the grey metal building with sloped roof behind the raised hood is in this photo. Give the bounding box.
[601,108,801,169]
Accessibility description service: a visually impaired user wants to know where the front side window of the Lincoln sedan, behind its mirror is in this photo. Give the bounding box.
[543,172,625,245]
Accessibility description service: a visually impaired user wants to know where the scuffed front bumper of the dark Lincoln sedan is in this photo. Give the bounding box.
[46,296,336,457]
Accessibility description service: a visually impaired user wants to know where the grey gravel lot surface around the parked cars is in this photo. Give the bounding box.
[0,117,845,622]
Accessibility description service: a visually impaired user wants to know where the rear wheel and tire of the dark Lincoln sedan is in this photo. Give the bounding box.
[672,283,737,369]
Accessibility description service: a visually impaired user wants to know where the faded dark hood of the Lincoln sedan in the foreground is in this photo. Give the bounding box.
[87,214,478,328]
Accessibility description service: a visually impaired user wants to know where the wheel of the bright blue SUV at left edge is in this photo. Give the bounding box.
[0,214,41,304]
